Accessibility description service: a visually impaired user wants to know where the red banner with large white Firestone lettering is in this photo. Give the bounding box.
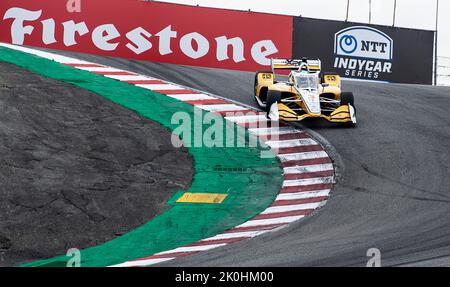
[0,0,293,71]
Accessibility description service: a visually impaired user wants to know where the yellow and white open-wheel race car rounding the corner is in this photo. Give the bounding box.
[254,58,356,126]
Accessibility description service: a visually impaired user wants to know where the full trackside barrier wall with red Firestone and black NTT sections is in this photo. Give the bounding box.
[0,0,434,84]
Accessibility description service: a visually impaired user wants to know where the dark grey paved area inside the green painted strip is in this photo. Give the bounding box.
[0,60,194,266]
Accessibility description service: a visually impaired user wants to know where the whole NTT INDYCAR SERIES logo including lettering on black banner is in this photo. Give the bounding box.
[334,26,394,80]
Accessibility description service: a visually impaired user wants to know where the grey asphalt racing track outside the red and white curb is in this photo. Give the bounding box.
[26,49,450,266]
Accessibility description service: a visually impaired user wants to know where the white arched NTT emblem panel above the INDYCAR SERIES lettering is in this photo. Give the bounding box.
[334,26,394,61]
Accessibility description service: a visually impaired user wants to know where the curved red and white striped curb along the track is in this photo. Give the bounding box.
[0,43,334,267]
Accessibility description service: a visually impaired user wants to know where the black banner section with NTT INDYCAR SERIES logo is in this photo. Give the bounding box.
[293,18,434,84]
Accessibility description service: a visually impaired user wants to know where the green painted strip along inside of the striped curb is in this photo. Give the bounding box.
[0,48,283,267]
